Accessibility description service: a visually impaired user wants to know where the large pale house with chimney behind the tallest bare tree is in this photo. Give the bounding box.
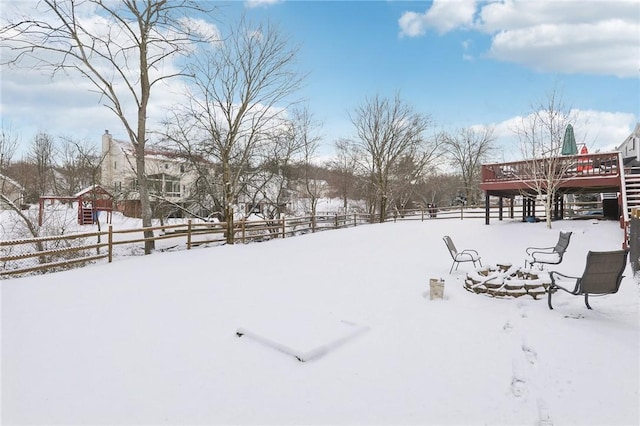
[101,130,196,217]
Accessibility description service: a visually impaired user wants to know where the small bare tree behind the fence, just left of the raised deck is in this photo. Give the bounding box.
[442,127,495,204]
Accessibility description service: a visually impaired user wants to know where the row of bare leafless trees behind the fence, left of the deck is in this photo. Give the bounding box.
[0,0,494,248]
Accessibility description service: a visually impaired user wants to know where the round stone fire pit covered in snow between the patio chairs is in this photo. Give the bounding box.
[464,263,551,299]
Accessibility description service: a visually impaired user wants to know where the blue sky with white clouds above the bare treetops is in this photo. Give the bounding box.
[1,0,640,160]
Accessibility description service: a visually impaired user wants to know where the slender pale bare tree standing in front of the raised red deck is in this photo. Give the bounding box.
[516,89,576,228]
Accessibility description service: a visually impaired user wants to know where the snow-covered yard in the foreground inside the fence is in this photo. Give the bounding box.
[0,219,640,425]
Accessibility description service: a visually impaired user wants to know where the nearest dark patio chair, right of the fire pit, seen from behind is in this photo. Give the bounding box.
[548,250,629,309]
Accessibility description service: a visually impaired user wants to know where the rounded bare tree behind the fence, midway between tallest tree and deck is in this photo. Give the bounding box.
[349,95,437,222]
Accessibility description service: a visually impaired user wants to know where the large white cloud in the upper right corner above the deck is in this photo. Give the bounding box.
[399,0,640,77]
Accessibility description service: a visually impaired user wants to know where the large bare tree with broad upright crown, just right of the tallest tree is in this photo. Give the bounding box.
[167,20,303,244]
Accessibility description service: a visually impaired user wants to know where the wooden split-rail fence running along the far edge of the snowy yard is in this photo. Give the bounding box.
[0,203,608,279]
